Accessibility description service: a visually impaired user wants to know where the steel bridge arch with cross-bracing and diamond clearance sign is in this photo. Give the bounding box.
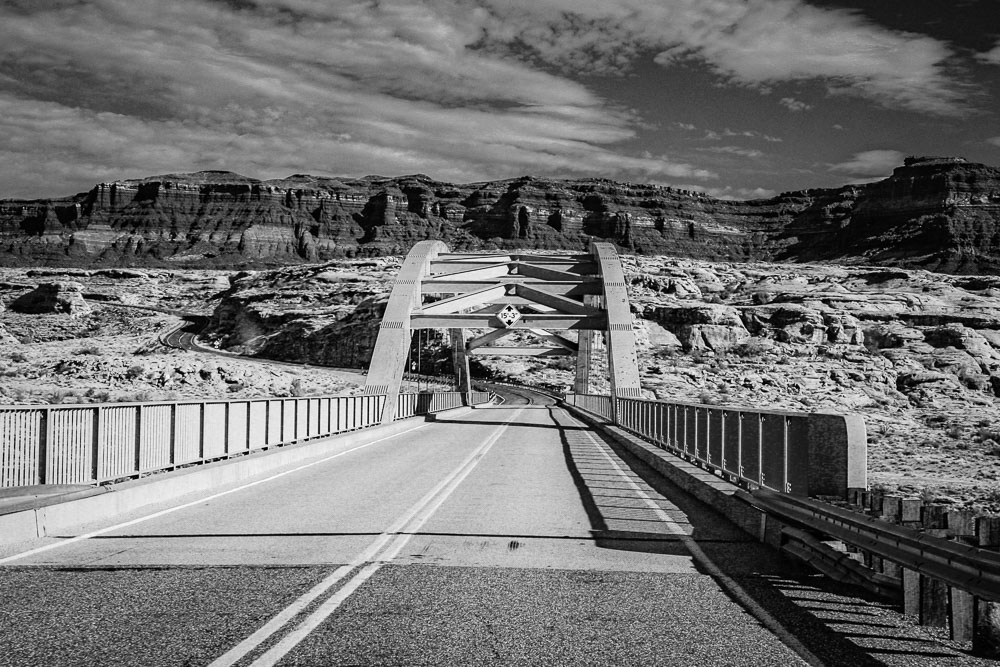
[365,241,640,422]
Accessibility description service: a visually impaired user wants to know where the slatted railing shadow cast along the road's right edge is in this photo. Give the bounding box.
[549,409,967,667]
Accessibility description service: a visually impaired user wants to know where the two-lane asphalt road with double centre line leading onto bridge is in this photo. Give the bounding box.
[0,404,984,666]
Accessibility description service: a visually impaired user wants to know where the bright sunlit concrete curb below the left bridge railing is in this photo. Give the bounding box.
[0,418,426,545]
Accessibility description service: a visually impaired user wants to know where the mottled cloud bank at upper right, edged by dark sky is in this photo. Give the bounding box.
[479,0,968,116]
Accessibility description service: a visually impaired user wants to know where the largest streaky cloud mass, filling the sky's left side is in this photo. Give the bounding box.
[0,0,717,196]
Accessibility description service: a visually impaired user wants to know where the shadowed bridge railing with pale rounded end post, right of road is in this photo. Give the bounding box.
[565,394,867,497]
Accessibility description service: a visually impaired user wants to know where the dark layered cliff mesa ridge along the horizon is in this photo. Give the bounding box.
[0,158,1000,274]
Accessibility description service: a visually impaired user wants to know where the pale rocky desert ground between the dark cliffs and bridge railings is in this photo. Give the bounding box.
[0,256,1000,513]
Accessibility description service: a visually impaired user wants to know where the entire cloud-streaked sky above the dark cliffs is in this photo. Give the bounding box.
[0,0,1000,199]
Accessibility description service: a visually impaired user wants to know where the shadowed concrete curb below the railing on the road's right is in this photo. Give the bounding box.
[561,403,767,541]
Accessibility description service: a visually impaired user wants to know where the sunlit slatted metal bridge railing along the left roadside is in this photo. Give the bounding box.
[0,392,491,487]
